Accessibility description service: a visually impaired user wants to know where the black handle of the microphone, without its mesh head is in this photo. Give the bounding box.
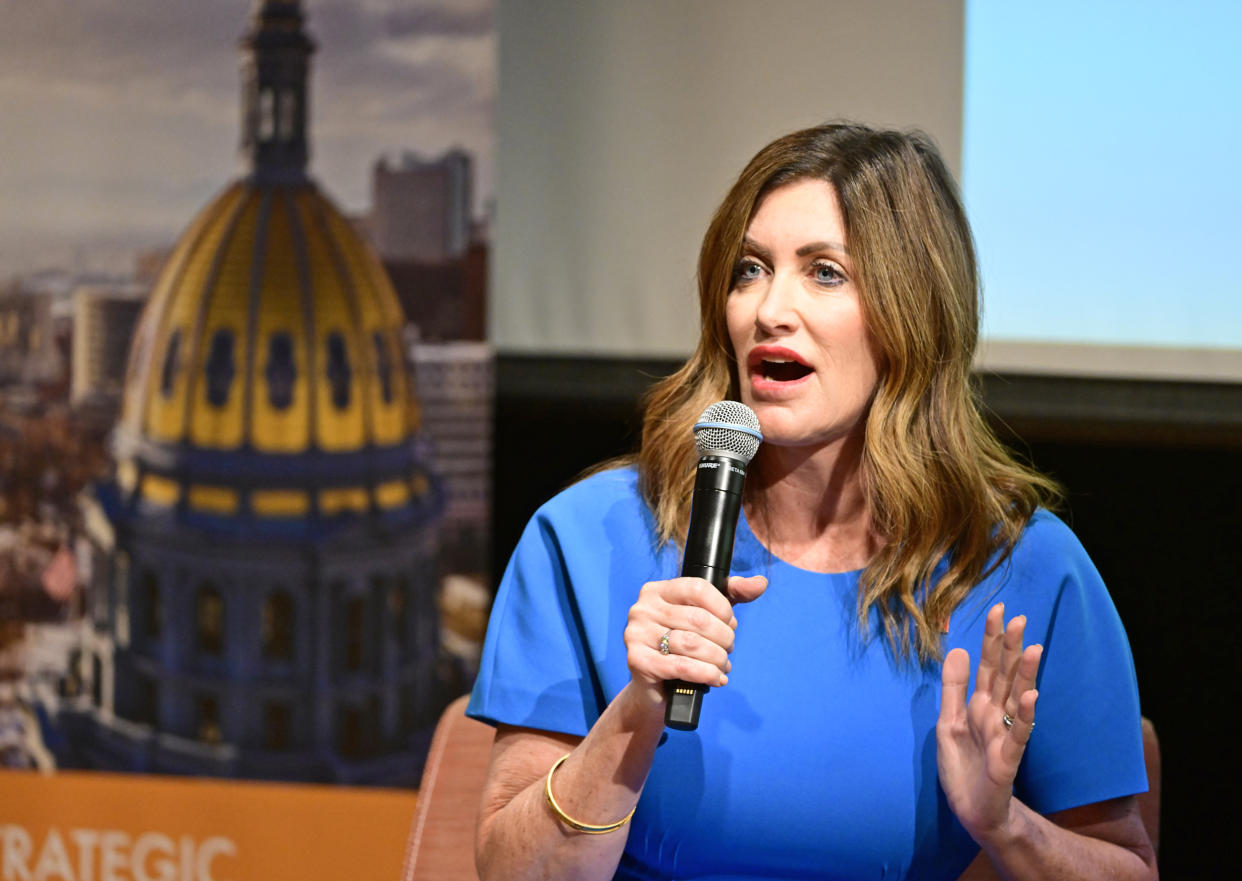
[664,454,746,731]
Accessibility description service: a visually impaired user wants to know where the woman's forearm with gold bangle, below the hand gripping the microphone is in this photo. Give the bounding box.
[477,683,664,881]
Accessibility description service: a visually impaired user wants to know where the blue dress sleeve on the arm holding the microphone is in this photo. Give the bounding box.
[466,470,656,736]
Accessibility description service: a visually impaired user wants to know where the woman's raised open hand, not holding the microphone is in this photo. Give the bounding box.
[935,604,1043,844]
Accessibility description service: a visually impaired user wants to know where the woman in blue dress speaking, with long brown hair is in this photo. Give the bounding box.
[469,124,1156,881]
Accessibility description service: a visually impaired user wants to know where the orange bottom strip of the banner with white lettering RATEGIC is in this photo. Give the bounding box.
[0,770,417,881]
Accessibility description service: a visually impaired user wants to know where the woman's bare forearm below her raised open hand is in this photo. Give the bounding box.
[980,799,1159,881]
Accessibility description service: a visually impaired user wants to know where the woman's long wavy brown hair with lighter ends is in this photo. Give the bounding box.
[637,123,1059,661]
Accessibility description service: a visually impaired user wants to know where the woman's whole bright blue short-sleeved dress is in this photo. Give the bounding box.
[467,468,1146,881]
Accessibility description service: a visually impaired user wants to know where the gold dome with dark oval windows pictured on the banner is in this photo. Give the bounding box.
[117,175,428,518]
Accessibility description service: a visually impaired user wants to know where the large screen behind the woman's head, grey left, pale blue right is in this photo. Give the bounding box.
[489,0,1242,380]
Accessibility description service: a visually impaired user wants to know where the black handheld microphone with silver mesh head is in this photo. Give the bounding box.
[664,400,764,731]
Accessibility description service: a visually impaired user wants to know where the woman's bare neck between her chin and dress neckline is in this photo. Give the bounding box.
[745,436,879,572]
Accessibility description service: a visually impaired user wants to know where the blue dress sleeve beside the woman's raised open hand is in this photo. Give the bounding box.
[1002,512,1148,814]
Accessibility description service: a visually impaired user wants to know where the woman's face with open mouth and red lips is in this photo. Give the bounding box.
[725,180,879,446]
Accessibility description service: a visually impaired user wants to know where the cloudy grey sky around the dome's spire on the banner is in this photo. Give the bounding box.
[0,0,497,278]
